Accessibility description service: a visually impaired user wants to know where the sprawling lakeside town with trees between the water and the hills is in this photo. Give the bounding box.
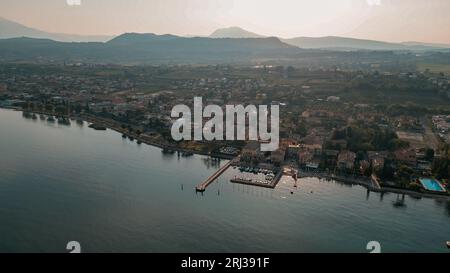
[0,64,450,195]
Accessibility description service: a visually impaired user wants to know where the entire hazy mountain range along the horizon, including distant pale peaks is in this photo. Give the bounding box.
[0,19,450,64]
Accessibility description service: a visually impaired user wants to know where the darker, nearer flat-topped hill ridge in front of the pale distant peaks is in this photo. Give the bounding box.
[0,33,301,64]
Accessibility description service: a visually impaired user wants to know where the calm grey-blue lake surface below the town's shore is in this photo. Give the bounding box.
[0,107,450,252]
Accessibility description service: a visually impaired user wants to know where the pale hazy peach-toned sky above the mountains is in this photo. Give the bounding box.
[0,0,450,43]
